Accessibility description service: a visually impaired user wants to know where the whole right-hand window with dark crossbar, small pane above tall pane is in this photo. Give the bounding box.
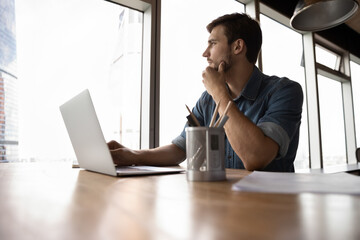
[315,36,356,167]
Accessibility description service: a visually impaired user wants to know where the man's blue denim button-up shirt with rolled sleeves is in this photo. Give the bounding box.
[172,67,303,172]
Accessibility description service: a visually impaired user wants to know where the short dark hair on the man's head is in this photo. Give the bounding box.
[206,13,262,63]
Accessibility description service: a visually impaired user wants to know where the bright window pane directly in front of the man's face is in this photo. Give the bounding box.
[159,0,244,145]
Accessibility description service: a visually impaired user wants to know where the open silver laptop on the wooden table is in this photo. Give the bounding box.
[60,89,184,176]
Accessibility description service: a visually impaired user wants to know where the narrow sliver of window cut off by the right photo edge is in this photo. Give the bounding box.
[350,58,360,148]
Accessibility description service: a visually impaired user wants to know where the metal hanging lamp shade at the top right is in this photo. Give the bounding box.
[290,0,358,32]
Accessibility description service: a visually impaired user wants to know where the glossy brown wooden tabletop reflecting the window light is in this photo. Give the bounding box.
[0,163,360,240]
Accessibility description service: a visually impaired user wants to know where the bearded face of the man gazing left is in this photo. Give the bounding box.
[203,25,231,71]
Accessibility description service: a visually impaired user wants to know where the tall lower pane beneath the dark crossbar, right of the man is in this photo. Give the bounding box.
[318,75,346,167]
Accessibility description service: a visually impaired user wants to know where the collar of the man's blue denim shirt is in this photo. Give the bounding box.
[234,66,263,101]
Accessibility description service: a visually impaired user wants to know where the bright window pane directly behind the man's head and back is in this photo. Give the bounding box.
[260,14,309,170]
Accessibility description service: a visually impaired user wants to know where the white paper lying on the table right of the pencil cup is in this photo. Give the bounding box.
[232,171,360,195]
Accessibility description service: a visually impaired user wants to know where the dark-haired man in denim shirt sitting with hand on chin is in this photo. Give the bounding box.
[108,13,303,172]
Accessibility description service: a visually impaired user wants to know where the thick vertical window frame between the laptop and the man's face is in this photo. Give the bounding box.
[105,0,161,149]
